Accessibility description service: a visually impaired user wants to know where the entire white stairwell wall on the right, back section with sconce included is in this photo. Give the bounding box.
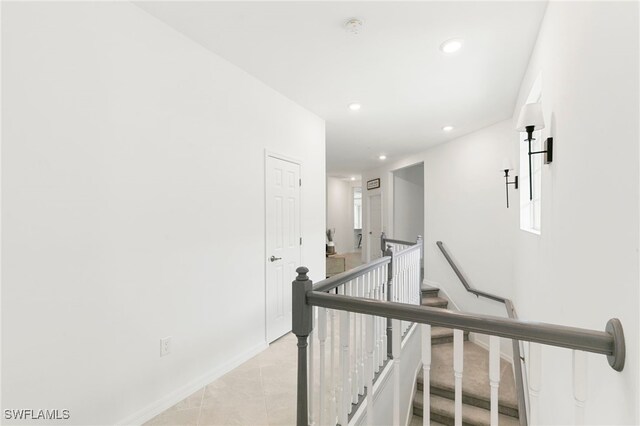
[363,2,640,425]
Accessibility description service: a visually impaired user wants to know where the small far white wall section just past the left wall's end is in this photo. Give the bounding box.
[327,177,353,253]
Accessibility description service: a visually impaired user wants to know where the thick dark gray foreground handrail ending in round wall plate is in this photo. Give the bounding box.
[306,291,625,371]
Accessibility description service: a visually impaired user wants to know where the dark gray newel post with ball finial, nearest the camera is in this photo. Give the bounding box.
[291,266,313,426]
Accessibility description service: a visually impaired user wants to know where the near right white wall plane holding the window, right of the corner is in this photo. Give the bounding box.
[513,2,640,425]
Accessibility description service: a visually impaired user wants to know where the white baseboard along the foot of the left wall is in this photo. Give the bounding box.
[116,342,269,425]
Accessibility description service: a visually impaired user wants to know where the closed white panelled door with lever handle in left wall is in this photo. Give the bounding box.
[265,156,302,343]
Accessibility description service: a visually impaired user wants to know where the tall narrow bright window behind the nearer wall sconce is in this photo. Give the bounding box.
[518,75,543,234]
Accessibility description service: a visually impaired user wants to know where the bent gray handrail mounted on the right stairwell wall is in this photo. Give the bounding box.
[436,241,528,426]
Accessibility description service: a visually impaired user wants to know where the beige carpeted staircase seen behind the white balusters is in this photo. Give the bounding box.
[411,285,519,426]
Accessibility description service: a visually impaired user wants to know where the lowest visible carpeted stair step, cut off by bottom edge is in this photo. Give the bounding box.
[413,391,520,426]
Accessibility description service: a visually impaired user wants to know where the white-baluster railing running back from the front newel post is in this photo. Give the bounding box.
[293,237,422,425]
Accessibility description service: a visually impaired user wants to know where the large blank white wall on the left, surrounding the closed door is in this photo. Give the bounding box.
[2,2,325,424]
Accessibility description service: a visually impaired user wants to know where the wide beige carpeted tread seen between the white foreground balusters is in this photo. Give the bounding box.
[418,341,518,416]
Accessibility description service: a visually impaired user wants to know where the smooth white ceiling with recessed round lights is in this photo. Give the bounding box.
[136,1,546,176]
